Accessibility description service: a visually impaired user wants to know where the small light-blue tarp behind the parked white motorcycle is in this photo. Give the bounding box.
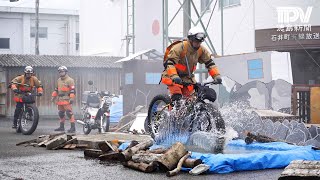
[110,95,123,122]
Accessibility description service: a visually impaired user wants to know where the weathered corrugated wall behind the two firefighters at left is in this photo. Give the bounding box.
[6,67,121,116]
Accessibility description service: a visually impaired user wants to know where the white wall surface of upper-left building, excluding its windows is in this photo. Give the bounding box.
[0,8,79,55]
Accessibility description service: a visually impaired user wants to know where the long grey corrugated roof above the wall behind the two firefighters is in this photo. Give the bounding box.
[0,54,122,68]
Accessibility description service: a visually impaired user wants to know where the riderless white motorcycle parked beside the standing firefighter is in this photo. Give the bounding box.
[77,80,118,134]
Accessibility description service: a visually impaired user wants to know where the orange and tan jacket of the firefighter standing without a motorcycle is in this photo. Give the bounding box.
[52,75,75,105]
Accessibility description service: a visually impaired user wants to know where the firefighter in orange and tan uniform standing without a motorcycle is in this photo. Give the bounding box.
[51,66,76,133]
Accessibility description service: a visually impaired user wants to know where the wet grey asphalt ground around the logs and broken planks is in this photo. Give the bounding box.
[0,118,283,180]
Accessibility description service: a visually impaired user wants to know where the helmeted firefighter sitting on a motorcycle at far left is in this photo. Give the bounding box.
[11,66,43,129]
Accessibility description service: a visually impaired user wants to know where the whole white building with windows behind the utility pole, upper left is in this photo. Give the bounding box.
[0,6,80,55]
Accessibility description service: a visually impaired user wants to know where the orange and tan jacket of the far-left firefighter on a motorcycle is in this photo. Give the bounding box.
[11,75,43,102]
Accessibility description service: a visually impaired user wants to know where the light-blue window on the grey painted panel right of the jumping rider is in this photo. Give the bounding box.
[247,59,263,79]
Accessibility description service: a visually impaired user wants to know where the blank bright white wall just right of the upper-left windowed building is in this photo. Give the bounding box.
[80,0,126,56]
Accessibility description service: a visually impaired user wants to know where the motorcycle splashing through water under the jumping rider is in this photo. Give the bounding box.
[145,82,225,152]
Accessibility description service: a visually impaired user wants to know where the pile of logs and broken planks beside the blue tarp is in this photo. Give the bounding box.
[16,133,210,177]
